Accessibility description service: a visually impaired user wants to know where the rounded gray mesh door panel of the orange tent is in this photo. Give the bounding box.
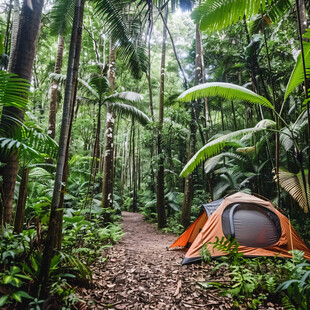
[222,203,281,248]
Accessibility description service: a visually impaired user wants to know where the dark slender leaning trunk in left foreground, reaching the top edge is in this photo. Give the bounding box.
[39,0,84,296]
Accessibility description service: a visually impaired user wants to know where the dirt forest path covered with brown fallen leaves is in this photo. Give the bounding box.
[83,212,231,310]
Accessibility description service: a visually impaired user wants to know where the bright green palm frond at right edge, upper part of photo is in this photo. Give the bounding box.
[284,37,310,101]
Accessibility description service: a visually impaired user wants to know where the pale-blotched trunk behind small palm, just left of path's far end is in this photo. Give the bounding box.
[102,41,116,208]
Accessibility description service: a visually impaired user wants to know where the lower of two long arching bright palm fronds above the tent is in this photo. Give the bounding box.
[180,120,275,177]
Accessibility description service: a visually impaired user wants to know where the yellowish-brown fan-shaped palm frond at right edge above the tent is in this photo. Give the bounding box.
[279,169,310,212]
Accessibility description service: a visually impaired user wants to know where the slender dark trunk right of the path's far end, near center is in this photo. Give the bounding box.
[157,8,168,229]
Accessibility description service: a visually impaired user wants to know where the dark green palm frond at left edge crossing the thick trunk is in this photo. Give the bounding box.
[0,71,30,109]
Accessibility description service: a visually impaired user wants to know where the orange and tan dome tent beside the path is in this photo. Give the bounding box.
[170,192,310,265]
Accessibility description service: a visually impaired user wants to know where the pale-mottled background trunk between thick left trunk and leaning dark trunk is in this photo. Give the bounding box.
[47,35,65,139]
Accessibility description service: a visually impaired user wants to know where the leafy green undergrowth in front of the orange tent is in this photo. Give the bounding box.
[197,237,310,310]
